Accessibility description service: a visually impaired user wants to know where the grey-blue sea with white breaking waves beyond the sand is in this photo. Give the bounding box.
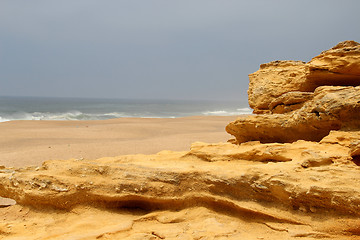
[0,97,251,122]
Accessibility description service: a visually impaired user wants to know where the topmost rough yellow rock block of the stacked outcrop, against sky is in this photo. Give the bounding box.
[248,41,360,113]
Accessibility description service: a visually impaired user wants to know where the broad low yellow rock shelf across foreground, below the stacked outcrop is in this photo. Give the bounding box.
[0,140,360,239]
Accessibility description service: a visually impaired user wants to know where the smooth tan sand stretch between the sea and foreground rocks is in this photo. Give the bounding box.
[0,116,236,167]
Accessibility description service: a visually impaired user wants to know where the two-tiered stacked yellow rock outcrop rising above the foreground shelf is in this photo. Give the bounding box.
[231,41,360,143]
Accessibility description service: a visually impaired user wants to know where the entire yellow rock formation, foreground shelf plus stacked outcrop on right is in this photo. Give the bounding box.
[0,41,360,239]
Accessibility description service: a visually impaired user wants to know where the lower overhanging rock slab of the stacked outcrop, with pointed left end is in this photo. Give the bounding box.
[226,86,360,143]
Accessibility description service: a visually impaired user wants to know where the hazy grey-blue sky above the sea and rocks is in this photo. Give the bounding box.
[0,0,360,100]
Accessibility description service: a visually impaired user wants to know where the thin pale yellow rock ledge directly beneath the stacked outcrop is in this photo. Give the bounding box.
[186,140,348,167]
